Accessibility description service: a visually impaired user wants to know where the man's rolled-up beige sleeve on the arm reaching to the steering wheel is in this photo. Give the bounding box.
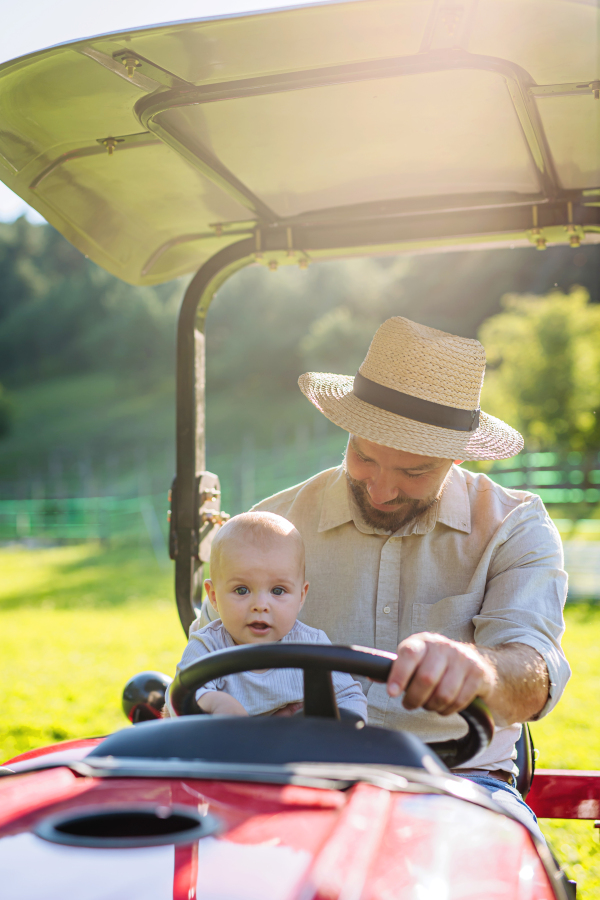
[473,497,571,718]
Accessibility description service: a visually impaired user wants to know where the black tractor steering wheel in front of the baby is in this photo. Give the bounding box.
[170,643,494,769]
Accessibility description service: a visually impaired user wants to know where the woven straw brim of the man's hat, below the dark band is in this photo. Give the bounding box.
[298,372,523,460]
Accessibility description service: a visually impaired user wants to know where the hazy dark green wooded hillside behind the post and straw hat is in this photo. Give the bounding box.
[0,219,600,500]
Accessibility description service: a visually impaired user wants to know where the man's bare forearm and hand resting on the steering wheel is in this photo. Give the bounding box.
[388,632,550,725]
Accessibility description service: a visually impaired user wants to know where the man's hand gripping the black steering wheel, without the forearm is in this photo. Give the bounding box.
[387,632,496,716]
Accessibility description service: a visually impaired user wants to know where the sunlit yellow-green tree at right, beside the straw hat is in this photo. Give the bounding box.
[479,287,600,452]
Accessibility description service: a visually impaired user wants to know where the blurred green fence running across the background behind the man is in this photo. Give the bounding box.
[0,442,600,546]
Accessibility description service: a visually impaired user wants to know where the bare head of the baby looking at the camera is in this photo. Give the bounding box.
[204,512,308,644]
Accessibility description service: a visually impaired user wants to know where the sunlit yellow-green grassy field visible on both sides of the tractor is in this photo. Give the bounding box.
[0,544,600,900]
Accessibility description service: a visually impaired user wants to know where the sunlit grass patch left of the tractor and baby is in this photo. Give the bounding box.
[0,544,185,759]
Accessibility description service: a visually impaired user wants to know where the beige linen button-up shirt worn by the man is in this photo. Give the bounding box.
[246,465,570,771]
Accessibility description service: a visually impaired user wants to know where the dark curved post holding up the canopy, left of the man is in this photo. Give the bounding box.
[175,238,254,635]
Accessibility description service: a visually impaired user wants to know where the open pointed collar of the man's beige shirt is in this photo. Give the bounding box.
[317,464,471,536]
